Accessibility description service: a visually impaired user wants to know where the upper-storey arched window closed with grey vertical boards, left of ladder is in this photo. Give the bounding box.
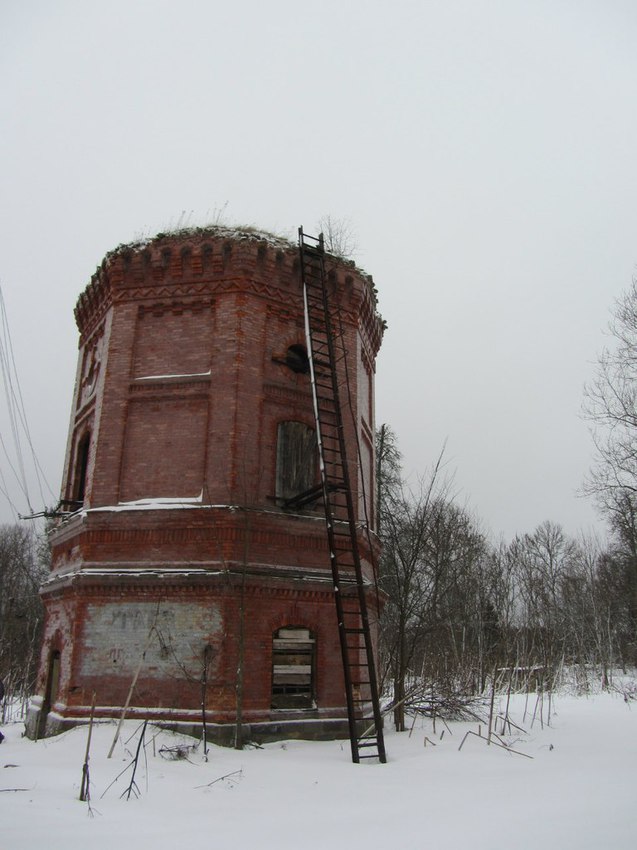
[276,422,317,500]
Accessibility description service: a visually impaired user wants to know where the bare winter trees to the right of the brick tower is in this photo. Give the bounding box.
[376,283,637,729]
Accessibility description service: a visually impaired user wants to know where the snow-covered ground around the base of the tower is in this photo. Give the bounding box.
[0,694,637,850]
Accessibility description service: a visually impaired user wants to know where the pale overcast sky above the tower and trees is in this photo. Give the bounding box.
[0,0,637,538]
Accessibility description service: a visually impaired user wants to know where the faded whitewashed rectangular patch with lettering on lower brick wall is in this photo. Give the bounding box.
[81,602,222,678]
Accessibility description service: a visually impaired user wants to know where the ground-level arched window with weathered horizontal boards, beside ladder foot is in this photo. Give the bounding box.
[272,626,316,709]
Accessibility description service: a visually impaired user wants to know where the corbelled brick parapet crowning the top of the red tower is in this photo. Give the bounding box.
[75,227,384,358]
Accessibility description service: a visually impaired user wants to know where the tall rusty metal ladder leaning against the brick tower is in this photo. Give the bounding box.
[290,227,387,764]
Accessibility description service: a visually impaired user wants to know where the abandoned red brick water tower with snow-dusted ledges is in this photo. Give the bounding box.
[27,227,383,743]
